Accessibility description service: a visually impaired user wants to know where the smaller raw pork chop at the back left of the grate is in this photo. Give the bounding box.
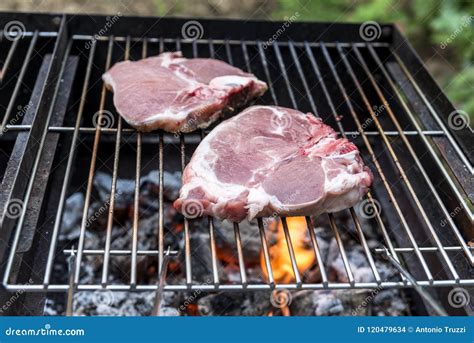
[102,52,267,132]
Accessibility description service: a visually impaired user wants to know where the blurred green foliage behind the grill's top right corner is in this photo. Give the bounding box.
[273,0,474,118]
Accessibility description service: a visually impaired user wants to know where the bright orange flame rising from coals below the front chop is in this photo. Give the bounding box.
[260,217,316,283]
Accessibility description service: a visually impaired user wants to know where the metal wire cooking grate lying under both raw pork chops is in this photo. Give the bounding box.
[1,14,474,304]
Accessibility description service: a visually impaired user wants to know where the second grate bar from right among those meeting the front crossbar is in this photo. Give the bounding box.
[321,44,433,282]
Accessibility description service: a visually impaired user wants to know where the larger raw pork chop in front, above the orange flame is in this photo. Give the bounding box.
[174,106,373,222]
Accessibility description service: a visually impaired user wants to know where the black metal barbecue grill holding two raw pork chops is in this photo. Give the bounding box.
[0,13,474,314]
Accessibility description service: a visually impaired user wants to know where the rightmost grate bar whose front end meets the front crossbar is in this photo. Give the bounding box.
[337,46,459,281]
